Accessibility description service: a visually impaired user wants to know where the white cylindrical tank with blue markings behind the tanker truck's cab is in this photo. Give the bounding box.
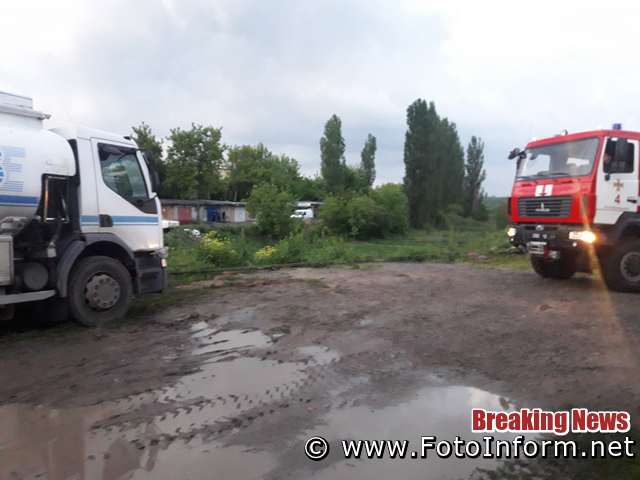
[0,92,76,234]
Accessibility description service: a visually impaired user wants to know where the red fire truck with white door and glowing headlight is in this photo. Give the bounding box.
[507,124,640,292]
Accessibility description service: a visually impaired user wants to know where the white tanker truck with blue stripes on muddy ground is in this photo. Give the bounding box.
[0,92,166,326]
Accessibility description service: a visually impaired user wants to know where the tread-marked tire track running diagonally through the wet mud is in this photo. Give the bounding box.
[75,322,350,458]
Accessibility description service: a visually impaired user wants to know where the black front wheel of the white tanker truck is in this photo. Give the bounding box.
[69,256,133,327]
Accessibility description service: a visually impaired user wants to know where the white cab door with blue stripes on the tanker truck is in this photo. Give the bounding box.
[88,139,162,251]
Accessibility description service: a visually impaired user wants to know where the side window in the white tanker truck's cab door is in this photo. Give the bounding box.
[98,144,148,204]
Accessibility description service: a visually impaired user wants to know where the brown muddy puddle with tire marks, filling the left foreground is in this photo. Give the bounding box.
[0,322,338,480]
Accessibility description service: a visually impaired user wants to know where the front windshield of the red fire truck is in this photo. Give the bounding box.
[518,138,598,178]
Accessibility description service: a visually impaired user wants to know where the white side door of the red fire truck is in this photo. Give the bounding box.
[594,138,639,225]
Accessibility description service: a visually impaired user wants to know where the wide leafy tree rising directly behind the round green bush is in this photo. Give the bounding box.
[227,144,301,201]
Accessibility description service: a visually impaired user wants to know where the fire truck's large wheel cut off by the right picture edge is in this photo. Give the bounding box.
[601,240,640,292]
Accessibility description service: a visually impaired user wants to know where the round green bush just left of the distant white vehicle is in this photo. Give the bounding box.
[247,183,296,238]
